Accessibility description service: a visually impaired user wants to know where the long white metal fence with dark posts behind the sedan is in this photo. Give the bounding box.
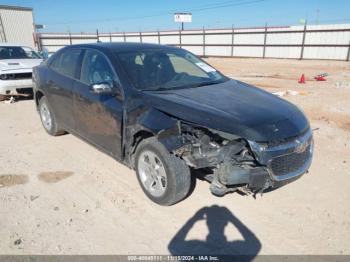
[38,24,350,61]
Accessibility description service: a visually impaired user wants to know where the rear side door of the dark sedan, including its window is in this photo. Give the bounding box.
[46,48,82,130]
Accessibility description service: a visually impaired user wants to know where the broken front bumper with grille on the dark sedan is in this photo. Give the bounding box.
[211,129,313,192]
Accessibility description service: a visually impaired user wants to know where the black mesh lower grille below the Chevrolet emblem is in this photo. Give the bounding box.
[271,145,311,176]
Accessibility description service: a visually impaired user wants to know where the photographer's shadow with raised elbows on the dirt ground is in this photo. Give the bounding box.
[168,205,261,261]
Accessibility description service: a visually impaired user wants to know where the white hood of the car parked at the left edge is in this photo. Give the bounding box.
[0,58,43,73]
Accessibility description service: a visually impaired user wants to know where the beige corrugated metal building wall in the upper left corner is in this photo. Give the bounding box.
[0,7,34,47]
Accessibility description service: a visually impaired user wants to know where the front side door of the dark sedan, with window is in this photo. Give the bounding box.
[73,49,123,159]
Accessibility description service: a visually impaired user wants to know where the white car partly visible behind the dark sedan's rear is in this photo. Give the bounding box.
[0,43,42,96]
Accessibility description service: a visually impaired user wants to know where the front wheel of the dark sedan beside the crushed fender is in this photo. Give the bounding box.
[135,137,191,206]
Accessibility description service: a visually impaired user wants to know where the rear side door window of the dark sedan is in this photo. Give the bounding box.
[51,49,81,78]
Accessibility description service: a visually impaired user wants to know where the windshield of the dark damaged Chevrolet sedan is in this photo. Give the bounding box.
[117,49,228,91]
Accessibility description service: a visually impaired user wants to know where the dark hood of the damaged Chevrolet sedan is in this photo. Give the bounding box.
[145,80,309,142]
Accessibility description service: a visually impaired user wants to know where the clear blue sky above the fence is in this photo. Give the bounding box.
[0,0,350,32]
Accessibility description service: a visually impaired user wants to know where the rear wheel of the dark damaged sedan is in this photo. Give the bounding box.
[39,96,65,136]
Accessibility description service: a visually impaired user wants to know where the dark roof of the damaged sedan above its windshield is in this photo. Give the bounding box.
[67,42,174,52]
